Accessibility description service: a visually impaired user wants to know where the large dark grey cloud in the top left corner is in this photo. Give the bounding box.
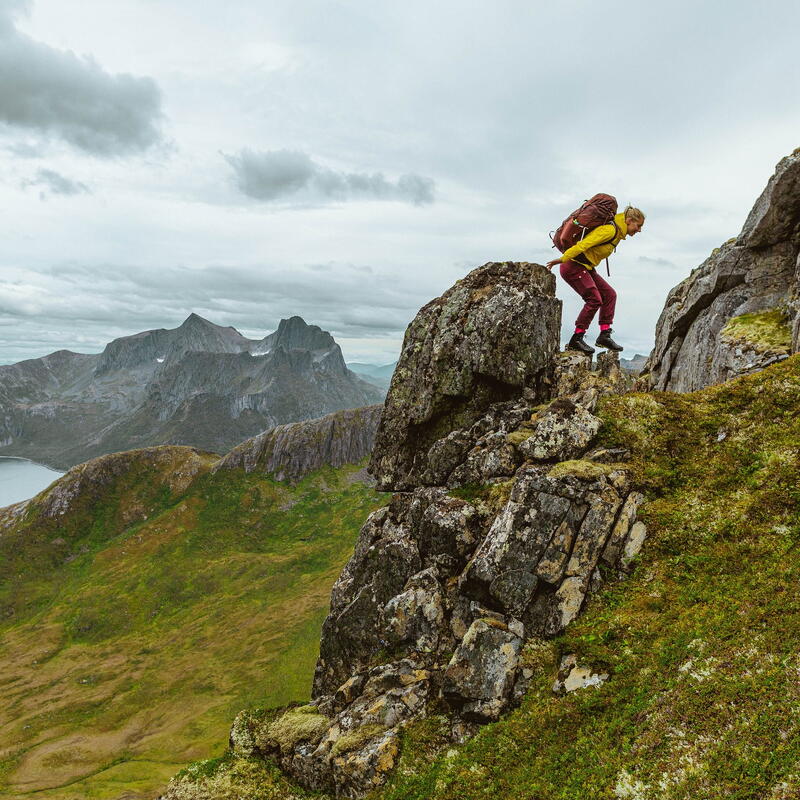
[0,0,161,156]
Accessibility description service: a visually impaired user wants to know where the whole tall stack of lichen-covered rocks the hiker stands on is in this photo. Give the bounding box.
[192,263,646,798]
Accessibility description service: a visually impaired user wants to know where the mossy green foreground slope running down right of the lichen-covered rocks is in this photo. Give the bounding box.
[169,356,800,800]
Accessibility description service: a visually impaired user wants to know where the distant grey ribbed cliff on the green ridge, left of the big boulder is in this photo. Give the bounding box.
[214,405,383,481]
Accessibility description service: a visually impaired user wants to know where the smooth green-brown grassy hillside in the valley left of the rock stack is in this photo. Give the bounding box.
[0,454,380,800]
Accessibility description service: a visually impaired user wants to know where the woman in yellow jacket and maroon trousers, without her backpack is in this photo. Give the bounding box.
[546,201,644,355]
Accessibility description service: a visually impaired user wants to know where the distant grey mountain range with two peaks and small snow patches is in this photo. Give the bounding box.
[0,314,384,468]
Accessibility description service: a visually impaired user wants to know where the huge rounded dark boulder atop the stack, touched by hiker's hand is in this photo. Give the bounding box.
[370,262,561,491]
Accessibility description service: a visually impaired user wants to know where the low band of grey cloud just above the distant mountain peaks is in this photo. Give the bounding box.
[0,263,446,364]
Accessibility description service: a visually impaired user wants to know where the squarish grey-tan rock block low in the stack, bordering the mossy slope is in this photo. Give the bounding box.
[443,619,522,721]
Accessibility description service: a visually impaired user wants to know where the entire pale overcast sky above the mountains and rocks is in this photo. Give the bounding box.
[0,0,800,363]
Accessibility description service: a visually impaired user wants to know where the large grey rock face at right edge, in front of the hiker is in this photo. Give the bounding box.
[645,149,800,392]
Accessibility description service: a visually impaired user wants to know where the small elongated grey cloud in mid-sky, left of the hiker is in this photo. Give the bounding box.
[223,148,434,206]
